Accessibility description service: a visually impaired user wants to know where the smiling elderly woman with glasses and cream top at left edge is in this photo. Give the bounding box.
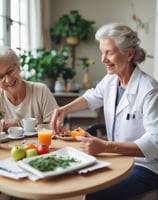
[0,46,58,130]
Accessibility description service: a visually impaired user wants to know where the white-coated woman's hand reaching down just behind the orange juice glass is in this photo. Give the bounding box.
[50,107,65,133]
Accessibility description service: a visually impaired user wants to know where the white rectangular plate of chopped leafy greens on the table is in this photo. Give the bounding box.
[18,147,96,178]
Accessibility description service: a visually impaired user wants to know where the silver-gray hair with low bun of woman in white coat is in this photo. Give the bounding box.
[95,23,146,64]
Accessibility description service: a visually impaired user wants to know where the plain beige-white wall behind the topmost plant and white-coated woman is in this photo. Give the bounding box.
[50,0,156,82]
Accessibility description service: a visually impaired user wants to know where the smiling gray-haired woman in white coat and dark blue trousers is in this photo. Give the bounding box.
[51,23,158,200]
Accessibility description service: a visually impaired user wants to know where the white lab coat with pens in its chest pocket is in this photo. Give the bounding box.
[83,67,158,173]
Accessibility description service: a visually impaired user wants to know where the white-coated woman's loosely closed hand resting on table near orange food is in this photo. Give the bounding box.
[76,132,108,155]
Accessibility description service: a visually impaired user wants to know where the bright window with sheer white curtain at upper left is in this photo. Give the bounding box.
[0,0,41,50]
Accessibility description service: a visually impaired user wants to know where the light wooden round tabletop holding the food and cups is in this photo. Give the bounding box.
[0,138,134,200]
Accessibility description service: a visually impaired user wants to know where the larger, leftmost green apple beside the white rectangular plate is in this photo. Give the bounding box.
[10,146,26,160]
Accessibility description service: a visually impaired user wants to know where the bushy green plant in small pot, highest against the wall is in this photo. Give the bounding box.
[50,10,95,45]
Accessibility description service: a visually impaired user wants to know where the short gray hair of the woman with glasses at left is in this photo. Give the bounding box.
[0,46,20,66]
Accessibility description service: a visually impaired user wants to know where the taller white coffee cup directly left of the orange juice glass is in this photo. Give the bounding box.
[21,117,37,132]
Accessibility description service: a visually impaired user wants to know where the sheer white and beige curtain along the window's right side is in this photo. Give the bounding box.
[28,0,51,49]
